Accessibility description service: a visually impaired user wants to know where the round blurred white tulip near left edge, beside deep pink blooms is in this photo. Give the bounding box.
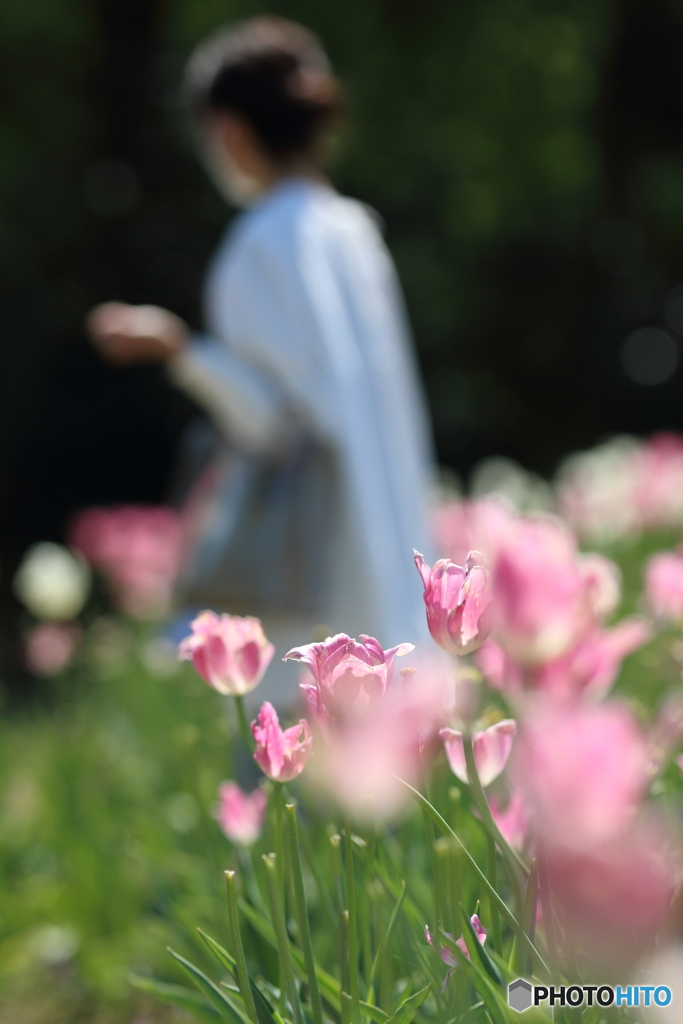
[13,542,90,622]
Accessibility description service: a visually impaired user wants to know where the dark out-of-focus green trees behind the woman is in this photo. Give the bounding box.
[5,0,683,647]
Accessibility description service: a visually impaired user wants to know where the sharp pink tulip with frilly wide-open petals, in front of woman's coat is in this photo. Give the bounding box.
[283,633,414,722]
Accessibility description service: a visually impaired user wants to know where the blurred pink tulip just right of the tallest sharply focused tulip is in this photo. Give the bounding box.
[493,517,589,665]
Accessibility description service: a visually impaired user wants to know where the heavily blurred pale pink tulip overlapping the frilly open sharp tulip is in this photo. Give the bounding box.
[321,662,454,819]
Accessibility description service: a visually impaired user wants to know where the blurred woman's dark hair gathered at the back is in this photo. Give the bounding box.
[184,17,341,160]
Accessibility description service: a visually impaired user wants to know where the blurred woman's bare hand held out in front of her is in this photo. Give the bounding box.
[85,302,189,366]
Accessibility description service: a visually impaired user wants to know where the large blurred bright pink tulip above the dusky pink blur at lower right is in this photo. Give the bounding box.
[512,702,648,848]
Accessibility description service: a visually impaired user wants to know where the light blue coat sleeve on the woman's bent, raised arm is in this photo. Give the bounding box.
[169,214,341,455]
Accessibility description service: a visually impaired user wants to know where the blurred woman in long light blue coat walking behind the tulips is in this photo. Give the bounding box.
[88,18,432,702]
